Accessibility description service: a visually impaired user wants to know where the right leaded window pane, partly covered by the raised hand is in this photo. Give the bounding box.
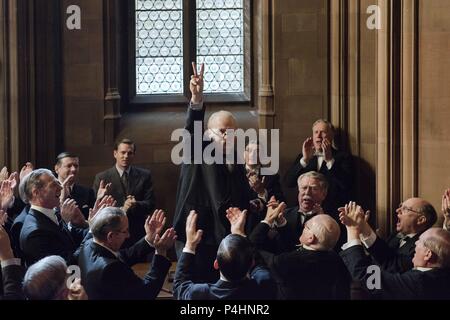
[197,0,244,93]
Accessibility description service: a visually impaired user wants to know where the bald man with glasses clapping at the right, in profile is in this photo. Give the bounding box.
[339,198,437,273]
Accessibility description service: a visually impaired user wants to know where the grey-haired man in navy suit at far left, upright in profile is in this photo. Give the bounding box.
[19,169,88,266]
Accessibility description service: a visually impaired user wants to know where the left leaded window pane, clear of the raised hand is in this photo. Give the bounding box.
[136,0,184,95]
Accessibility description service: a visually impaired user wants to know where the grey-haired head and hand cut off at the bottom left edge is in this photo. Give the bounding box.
[23,256,88,300]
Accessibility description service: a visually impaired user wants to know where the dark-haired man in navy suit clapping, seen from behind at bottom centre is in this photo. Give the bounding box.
[174,211,275,300]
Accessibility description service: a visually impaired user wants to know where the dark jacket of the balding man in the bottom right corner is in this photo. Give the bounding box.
[341,246,450,300]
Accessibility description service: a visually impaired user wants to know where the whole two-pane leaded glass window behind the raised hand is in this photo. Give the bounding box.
[134,0,250,101]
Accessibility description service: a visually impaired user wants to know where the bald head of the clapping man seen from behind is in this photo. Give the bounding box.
[300,214,341,251]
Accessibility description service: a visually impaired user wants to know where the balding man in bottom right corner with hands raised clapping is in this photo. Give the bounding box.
[341,203,450,300]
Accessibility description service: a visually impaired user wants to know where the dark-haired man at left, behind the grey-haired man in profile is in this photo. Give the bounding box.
[55,152,96,219]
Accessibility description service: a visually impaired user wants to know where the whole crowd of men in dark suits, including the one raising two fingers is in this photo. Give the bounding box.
[0,64,450,300]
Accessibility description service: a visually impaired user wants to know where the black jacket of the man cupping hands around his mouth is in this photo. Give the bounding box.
[285,149,353,216]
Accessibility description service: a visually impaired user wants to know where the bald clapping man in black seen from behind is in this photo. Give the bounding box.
[237,202,350,300]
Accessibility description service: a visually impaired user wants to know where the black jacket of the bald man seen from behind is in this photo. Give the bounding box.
[250,223,351,300]
